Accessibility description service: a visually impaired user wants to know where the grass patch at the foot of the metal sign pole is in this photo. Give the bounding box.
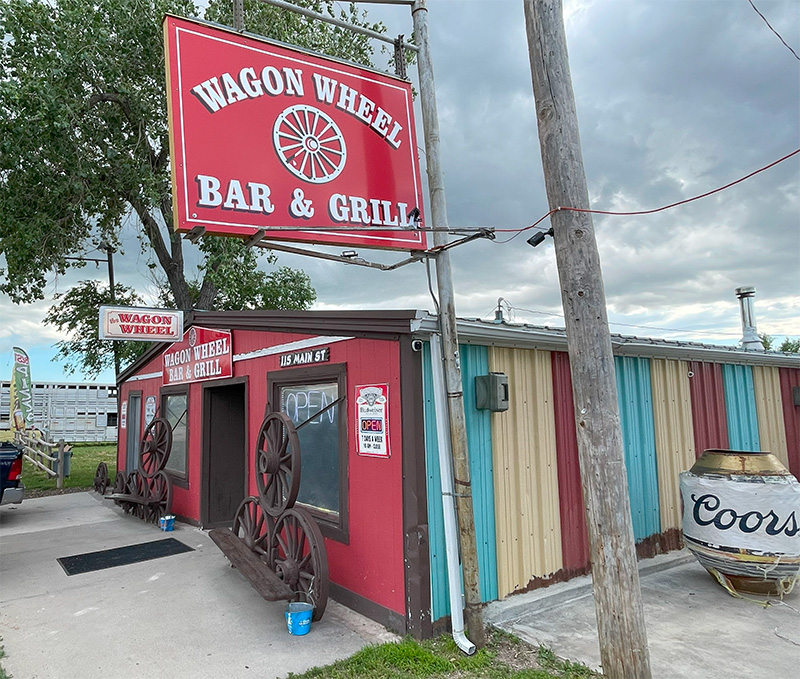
[289,630,601,679]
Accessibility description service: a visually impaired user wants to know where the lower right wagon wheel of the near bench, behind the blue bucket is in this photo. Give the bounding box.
[270,507,329,620]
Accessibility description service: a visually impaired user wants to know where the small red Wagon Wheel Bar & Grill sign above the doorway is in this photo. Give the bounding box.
[162,327,233,386]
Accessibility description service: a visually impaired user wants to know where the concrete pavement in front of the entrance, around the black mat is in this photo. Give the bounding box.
[0,493,397,679]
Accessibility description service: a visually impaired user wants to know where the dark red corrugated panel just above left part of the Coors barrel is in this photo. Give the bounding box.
[689,361,729,457]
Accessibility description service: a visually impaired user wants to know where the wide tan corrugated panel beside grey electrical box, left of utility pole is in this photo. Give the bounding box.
[489,347,563,597]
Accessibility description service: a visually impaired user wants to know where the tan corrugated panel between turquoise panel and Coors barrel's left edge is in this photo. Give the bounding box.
[650,359,696,532]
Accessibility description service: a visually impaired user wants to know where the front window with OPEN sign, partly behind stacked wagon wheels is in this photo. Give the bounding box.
[267,365,347,542]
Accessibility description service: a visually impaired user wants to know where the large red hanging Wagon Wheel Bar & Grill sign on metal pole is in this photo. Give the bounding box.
[164,16,426,250]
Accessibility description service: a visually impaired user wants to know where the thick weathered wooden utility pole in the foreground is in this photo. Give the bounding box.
[523,0,652,679]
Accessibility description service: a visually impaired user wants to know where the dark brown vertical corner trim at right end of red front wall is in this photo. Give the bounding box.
[400,337,433,639]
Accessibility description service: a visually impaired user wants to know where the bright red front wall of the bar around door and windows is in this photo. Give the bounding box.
[119,330,405,617]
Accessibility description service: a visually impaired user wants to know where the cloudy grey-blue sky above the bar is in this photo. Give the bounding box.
[0,0,800,381]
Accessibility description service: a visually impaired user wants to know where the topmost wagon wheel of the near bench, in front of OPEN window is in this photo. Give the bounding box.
[256,413,300,516]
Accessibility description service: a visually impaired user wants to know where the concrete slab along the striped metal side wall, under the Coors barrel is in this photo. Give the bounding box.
[484,551,800,679]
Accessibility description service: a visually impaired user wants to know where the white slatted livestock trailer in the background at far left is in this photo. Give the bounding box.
[0,380,117,443]
